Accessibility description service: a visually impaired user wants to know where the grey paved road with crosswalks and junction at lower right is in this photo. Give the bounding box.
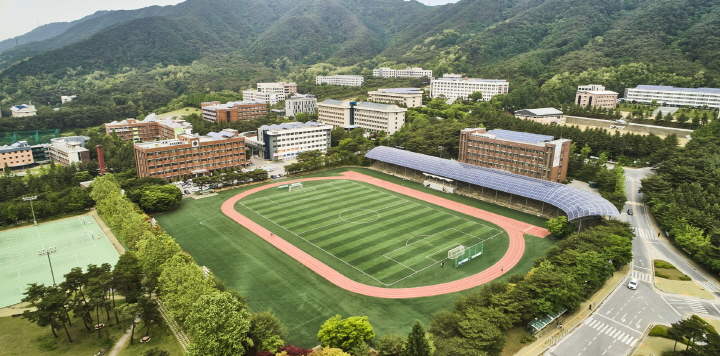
[550,168,720,356]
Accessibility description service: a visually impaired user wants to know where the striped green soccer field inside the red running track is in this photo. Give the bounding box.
[236,180,508,287]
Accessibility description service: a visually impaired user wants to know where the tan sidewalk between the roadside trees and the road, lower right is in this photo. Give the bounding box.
[515,264,630,356]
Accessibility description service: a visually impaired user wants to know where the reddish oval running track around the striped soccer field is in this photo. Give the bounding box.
[222,172,550,299]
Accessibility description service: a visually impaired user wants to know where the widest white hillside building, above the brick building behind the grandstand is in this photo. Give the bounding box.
[430,74,510,101]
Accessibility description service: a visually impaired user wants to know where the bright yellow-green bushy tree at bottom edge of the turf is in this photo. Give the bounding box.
[318,315,375,350]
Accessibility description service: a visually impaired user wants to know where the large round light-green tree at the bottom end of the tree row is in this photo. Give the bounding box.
[187,291,252,356]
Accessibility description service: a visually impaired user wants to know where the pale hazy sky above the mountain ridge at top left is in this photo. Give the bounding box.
[0,0,459,41]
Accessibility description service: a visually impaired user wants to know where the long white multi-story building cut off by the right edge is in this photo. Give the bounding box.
[625,85,720,108]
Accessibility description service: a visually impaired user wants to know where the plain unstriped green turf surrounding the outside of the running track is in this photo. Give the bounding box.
[155,168,553,347]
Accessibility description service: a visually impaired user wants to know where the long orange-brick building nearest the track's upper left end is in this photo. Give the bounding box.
[135,129,247,181]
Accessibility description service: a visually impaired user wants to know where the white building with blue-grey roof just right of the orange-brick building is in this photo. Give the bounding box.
[245,121,333,160]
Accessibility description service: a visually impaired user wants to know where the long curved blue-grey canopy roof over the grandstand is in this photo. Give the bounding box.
[365,146,620,220]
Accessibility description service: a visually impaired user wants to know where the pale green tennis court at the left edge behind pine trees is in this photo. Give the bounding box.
[0,215,119,307]
